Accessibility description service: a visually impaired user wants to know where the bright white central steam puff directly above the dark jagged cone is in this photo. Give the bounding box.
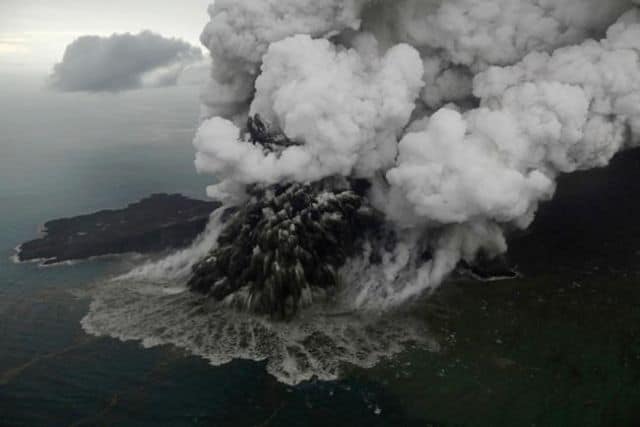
[195,35,422,199]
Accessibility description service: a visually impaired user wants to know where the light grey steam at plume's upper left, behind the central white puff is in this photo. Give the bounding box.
[200,0,365,117]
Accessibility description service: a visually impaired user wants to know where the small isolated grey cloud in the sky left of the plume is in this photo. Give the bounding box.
[49,31,202,92]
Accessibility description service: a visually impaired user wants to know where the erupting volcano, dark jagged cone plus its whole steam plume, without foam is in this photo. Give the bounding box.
[189,0,640,318]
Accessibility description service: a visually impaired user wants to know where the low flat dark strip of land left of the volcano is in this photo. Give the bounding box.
[18,194,220,264]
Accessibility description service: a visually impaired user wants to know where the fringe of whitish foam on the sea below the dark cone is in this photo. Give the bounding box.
[81,280,438,385]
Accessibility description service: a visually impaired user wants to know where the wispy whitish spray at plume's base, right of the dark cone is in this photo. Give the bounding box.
[339,222,507,311]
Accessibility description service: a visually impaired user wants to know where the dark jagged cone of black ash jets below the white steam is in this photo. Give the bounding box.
[189,179,379,318]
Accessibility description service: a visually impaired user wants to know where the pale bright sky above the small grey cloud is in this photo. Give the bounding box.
[0,0,213,73]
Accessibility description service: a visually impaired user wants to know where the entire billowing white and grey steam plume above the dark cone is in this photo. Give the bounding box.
[195,0,640,304]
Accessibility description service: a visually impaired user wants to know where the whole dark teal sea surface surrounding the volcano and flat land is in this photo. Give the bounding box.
[0,72,640,426]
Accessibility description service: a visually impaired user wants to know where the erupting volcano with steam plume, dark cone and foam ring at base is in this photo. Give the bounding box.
[75,0,640,384]
